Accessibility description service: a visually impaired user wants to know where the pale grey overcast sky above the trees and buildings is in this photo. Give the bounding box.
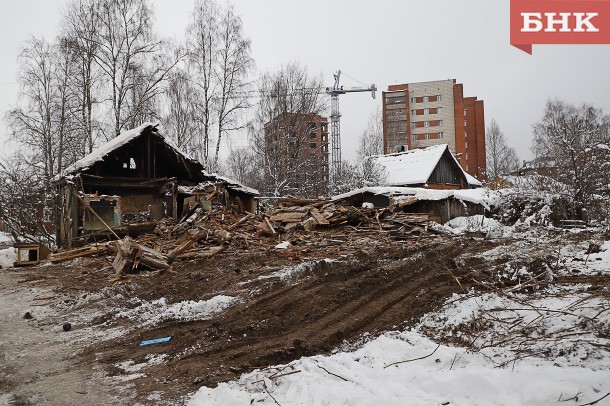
[0,0,610,159]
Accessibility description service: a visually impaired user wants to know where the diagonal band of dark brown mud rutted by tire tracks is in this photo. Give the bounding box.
[84,239,463,402]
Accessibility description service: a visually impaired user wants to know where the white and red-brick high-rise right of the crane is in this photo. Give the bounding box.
[382,79,487,179]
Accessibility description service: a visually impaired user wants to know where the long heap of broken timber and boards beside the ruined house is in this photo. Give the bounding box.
[46,193,434,276]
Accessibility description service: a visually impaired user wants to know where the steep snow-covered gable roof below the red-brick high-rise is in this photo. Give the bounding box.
[373,144,482,186]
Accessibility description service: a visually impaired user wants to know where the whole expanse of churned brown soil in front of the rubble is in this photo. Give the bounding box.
[0,228,600,404]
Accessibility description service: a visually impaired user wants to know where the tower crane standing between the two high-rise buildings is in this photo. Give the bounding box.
[326,70,377,192]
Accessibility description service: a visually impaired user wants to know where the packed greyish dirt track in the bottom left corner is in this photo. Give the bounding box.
[0,269,129,405]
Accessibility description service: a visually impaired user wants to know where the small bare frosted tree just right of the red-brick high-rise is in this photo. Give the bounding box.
[485,119,519,180]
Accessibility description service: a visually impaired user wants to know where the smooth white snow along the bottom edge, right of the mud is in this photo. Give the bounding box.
[188,331,610,406]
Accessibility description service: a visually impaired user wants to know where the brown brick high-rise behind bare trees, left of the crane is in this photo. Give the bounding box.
[265,113,329,197]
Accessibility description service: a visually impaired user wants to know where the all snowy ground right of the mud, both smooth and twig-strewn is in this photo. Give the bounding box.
[188,216,610,406]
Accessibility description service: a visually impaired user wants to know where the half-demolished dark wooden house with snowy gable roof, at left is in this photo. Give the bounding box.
[54,123,258,247]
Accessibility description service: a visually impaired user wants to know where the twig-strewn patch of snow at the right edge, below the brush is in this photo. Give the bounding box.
[419,285,610,371]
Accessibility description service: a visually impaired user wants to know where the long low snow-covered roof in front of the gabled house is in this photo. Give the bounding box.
[332,186,488,205]
